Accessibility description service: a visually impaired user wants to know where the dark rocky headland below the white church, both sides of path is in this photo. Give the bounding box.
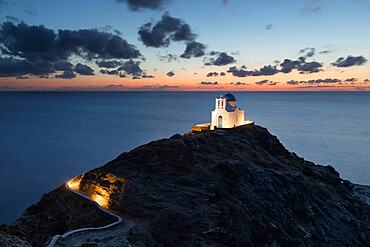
[3,125,370,246]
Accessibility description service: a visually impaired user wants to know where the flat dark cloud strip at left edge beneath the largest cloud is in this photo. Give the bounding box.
[0,57,55,77]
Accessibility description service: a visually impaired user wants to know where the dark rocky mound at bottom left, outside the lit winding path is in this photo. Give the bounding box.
[0,185,116,246]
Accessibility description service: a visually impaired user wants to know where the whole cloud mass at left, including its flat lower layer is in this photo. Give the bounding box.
[0,21,141,76]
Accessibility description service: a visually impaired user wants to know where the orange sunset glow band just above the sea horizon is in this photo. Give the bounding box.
[0,71,370,91]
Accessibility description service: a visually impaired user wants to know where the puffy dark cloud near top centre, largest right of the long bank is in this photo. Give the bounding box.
[138,12,196,48]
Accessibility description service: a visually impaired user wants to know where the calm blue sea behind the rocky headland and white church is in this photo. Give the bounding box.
[0,92,370,224]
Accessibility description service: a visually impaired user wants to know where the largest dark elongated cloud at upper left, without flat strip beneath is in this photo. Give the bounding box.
[0,22,140,61]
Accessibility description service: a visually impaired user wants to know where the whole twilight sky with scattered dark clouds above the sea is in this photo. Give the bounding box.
[0,0,370,91]
